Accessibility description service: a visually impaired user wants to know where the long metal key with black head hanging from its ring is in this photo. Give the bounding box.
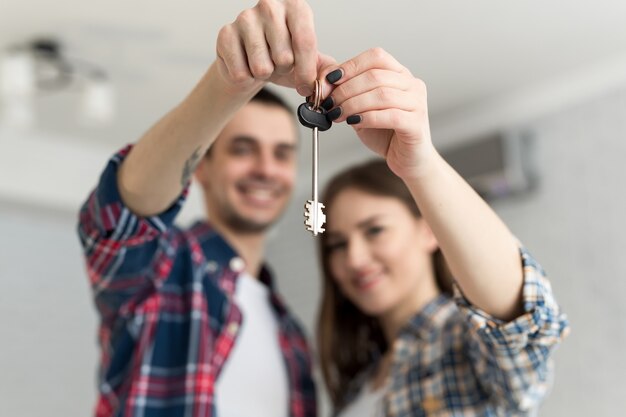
[298,80,332,236]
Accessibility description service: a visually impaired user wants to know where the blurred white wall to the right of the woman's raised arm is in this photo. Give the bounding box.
[488,89,626,417]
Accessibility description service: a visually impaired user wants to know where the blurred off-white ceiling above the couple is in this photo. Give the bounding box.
[0,0,626,182]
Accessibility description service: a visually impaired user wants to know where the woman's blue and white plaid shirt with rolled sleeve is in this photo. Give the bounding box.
[338,249,569,417]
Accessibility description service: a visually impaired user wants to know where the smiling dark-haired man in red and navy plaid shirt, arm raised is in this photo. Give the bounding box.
[79,0,334,417]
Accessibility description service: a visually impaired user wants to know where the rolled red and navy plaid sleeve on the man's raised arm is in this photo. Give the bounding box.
[78,145,188,322]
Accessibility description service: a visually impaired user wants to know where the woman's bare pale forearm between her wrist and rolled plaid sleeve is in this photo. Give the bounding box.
[405,148,523,320]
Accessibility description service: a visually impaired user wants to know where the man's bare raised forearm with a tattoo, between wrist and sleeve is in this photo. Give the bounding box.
[118,63,258,216]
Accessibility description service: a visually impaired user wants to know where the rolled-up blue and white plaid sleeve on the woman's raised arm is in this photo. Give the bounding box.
[454,247,569,412]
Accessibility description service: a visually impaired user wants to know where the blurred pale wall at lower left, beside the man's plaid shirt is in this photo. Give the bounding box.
[0,203,98,417]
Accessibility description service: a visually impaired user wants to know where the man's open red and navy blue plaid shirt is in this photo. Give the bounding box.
[78,147,316,417]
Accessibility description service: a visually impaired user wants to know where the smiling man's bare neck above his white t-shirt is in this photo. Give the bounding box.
[211,222,266,278]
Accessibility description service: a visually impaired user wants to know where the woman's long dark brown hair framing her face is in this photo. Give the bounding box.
[317,159,452,409]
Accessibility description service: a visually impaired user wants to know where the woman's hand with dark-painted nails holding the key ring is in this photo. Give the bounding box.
[322,48,432,178]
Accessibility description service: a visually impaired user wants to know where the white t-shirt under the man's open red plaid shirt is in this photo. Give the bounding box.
[215,273,289,417]
